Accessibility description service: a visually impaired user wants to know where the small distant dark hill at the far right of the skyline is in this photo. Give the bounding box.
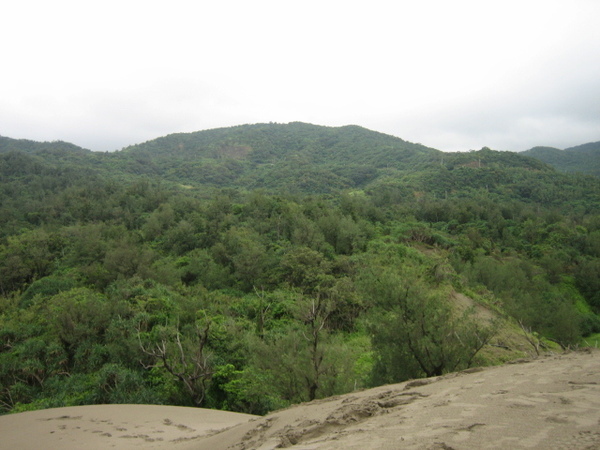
[521,142,600,177]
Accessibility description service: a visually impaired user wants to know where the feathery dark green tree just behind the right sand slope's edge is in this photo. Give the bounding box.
[363,268,494,384]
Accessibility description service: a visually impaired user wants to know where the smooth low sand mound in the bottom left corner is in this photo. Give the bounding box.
[0,405,257,450]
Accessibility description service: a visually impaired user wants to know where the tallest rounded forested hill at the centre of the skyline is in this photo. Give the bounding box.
[115,122,439,193]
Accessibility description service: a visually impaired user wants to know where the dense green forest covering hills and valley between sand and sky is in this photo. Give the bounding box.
[0,123,600,414]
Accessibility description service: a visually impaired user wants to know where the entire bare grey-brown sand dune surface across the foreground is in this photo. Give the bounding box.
[0,351,600,450]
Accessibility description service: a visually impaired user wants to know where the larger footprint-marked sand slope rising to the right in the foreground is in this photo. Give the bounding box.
[191,350,600,450]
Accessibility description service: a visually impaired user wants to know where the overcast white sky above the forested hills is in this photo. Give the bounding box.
[0,0,600,151]
